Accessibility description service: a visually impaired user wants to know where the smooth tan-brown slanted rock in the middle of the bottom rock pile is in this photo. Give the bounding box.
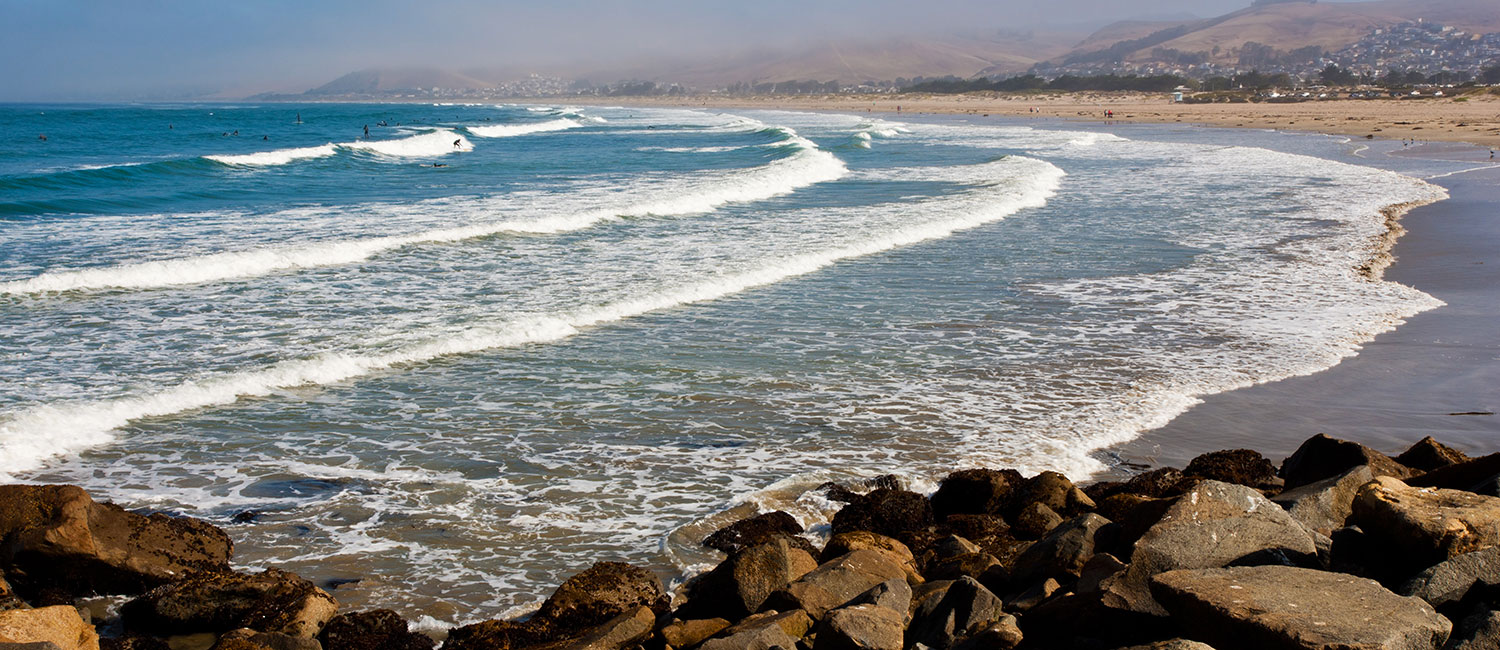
[761,549,906,620]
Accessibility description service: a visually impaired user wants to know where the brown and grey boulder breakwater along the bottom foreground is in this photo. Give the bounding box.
[0,435,1500,650]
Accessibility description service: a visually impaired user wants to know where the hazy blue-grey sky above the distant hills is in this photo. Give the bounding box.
[0,0,1250,101]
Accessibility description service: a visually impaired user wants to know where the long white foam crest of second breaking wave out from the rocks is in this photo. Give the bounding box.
[0,123,848,294]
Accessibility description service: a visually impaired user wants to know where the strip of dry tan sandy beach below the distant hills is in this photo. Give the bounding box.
[554,93,1500,147]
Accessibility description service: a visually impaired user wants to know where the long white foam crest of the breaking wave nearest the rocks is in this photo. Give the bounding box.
[0,156,1064,477]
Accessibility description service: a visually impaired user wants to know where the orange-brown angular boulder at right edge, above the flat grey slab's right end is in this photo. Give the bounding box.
[1349,476,1500,566]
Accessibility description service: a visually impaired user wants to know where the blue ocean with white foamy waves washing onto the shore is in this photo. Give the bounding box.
[0,104,1457,626]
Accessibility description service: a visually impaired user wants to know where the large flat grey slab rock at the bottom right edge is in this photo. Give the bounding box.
[1152,566,1452,650]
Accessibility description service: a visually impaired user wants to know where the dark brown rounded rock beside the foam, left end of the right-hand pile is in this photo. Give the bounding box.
[531,561,669,632]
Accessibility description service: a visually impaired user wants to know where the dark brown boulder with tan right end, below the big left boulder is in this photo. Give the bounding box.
[120,569,339,638]
